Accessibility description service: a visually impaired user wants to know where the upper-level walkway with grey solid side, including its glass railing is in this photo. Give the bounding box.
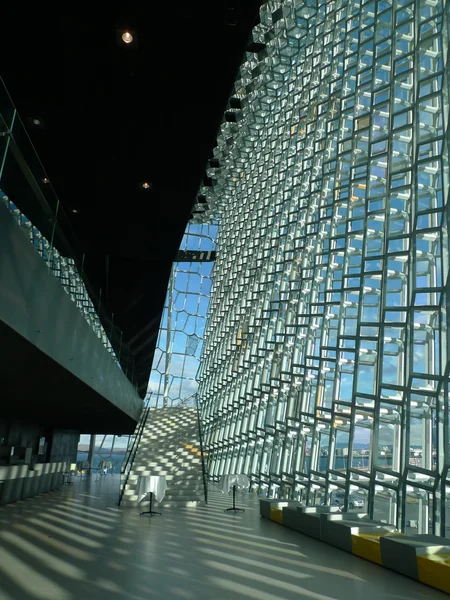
[0,78,142,436]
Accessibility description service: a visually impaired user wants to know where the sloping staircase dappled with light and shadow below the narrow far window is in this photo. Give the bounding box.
[121,408,205,508]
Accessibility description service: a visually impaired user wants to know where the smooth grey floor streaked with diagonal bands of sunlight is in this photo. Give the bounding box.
[0,476,447,600]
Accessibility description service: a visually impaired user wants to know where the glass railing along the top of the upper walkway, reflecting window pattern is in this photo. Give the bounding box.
[0,79,135,384]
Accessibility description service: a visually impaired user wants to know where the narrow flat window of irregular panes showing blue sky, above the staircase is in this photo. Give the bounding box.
[148,224,217,407]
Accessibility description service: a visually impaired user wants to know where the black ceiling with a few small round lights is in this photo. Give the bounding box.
[0,0,260,395]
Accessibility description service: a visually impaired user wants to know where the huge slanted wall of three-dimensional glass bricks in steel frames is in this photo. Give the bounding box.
[198,0,450,535]
